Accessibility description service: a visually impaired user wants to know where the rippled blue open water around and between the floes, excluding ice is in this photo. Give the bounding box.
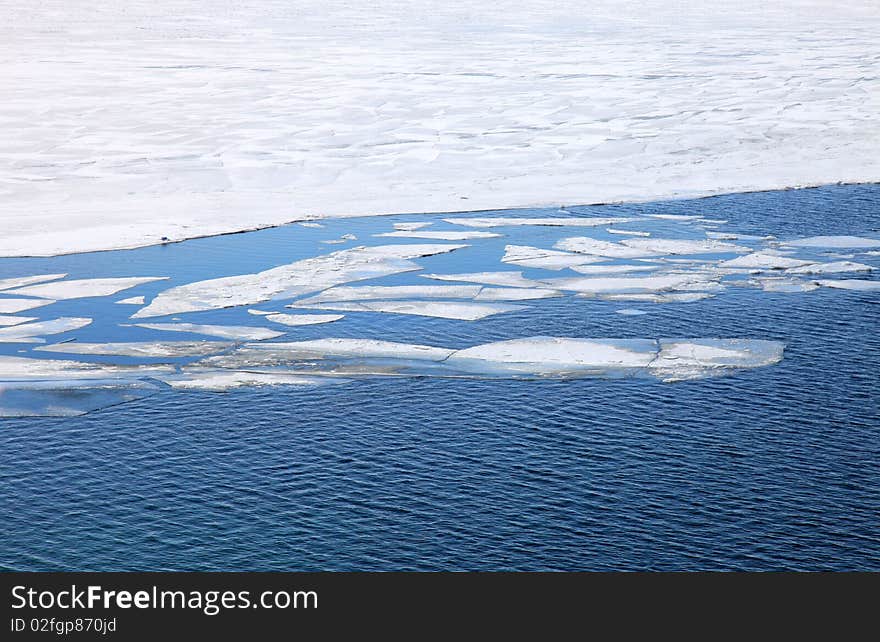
[0,185,880,570]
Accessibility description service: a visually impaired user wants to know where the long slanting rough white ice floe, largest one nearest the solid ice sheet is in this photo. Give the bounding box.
[132,244,467,318]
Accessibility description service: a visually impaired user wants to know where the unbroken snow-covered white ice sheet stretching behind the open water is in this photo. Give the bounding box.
[0,0,880,256]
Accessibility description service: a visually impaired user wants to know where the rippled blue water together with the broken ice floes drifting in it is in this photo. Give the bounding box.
[0,185,880,570]
